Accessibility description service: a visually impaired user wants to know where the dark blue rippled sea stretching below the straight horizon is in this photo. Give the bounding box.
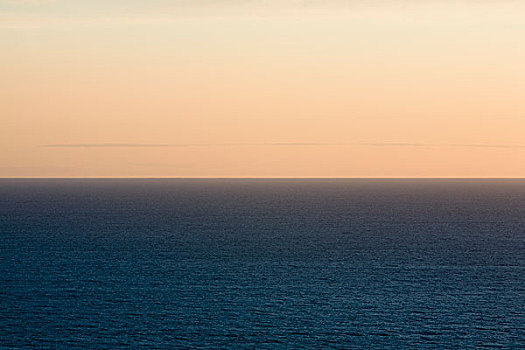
[0,179,525,349]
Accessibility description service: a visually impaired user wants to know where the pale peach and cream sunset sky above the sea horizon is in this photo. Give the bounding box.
[0,0,525,177]
